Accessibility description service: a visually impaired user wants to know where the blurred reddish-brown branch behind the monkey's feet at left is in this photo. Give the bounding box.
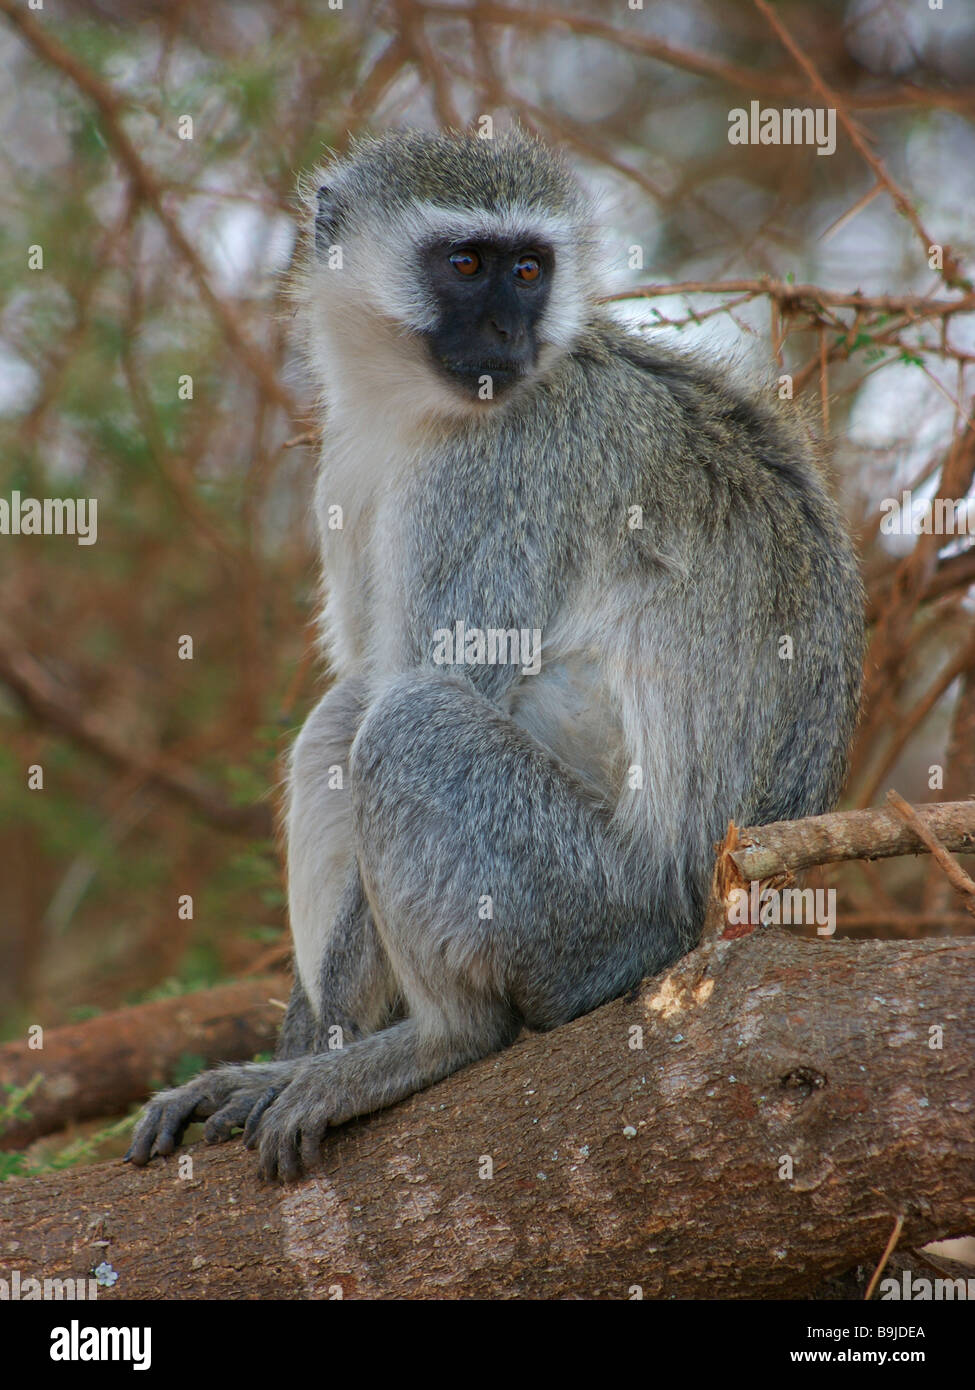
[0,976,291,1150]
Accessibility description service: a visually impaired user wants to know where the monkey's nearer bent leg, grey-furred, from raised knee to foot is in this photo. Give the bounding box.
[245,673,677,1179]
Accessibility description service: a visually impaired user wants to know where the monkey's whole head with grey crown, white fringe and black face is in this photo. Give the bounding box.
[295,132,598,435]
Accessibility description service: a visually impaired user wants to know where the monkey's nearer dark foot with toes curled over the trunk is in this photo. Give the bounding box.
[243,1058,355,1183]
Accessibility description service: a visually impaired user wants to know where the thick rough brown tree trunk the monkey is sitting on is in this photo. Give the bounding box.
[0,930,975,1298]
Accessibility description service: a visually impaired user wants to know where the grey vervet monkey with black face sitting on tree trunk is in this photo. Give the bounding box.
[128,131,862,1179]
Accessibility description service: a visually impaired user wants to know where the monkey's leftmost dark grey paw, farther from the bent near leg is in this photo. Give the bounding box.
[125,1062,293,1168]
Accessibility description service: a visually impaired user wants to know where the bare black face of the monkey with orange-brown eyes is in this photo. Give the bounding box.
[423,242,555,398]
